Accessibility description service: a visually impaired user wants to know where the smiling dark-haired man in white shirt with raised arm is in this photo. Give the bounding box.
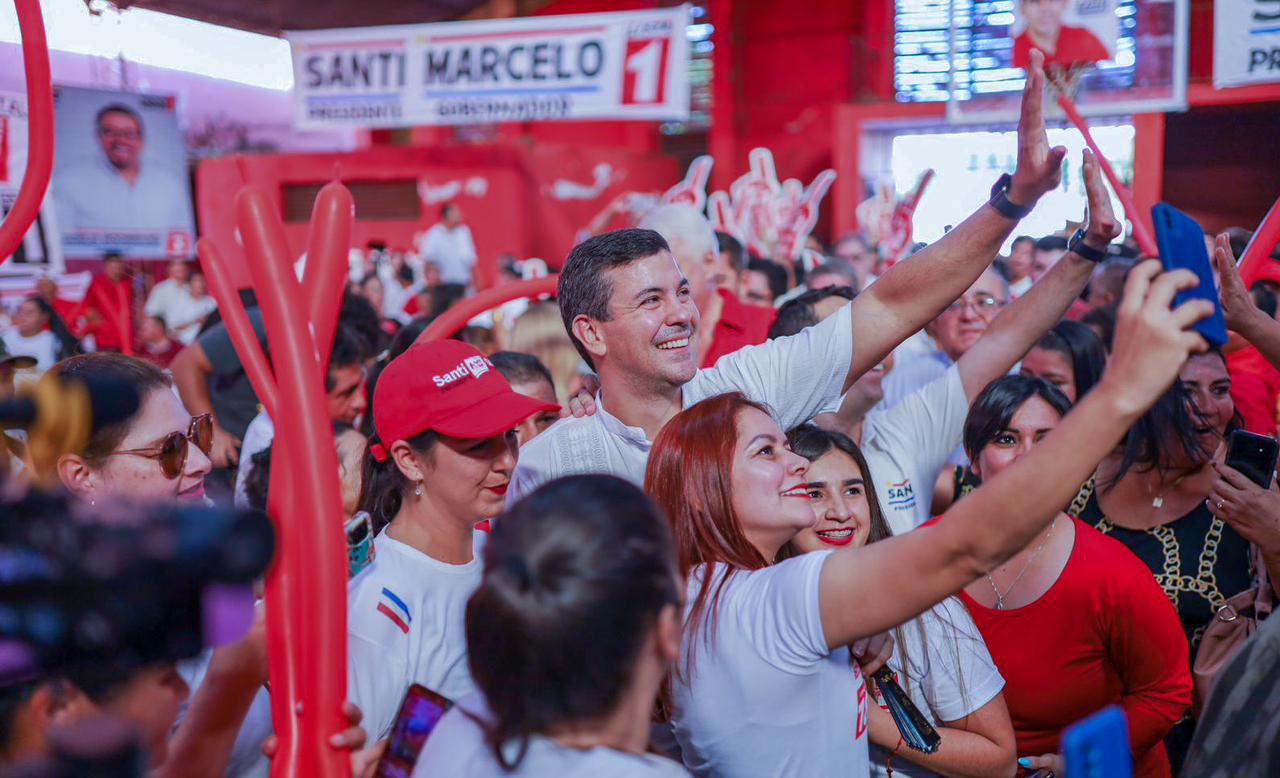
[507,56,1065,504]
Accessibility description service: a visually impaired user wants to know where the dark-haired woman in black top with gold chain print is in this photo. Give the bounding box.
[1076,349,1280,769]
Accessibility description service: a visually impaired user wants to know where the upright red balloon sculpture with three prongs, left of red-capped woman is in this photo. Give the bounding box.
[196,182,353,778]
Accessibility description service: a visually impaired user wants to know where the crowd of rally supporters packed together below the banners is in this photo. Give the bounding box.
[0,55,1280,778]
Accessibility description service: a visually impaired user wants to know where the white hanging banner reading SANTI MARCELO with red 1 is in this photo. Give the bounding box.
[285,6,689,128]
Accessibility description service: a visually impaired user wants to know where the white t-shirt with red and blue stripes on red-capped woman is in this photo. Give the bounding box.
[347,531,484,742]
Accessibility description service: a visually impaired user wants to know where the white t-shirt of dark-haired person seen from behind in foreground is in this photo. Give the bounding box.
[413,692,689,778]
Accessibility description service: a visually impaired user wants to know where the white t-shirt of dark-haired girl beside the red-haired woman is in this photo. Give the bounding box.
[870,598,1005,778]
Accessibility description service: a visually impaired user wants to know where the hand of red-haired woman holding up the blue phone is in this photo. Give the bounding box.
[1100,260,1213,413]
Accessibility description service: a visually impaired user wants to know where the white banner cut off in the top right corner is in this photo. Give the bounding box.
[1213,0,1280,88]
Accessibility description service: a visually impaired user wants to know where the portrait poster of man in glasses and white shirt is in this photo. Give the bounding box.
[52,87,196,260]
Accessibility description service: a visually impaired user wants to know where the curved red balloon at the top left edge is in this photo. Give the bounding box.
[0,0,54,262]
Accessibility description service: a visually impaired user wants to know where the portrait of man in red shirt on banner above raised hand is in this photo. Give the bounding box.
[1011,0,1119,68]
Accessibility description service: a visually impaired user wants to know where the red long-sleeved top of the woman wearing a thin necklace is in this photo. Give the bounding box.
[931,518,1192,777]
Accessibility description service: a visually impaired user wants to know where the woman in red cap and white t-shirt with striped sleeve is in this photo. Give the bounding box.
[347,340,558,738]
